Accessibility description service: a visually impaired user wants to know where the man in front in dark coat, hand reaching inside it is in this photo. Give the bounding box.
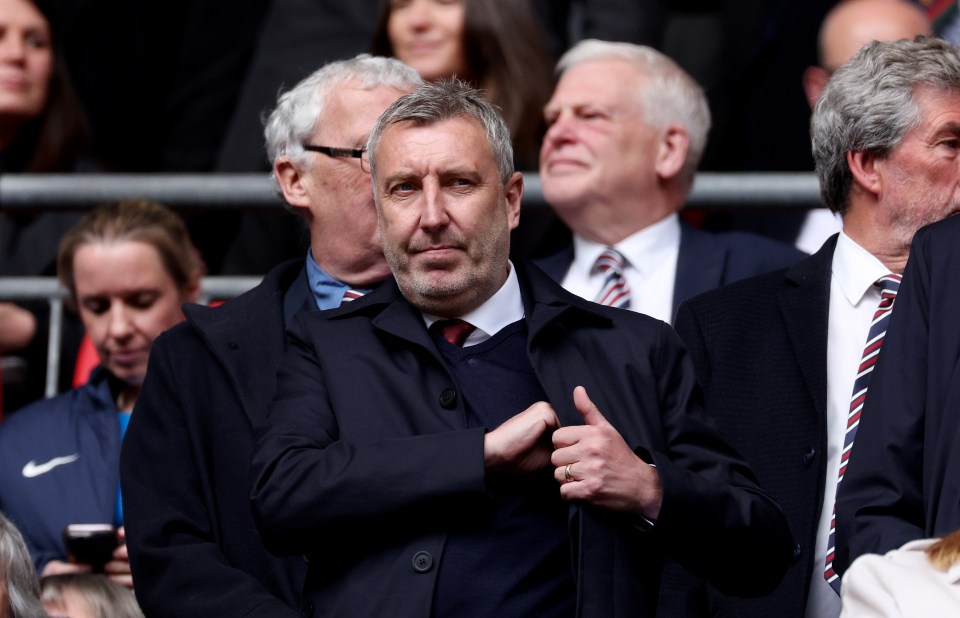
[252,81,792,617]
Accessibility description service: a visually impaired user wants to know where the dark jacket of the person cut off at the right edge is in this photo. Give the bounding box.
[834,217,960,573]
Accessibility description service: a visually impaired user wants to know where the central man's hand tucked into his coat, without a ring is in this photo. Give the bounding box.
[483,401,560,474]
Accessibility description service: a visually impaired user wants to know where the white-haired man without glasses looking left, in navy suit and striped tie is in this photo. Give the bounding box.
[537,41,804,322]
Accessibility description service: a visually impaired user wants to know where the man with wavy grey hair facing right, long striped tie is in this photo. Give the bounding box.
[676,37,960,617]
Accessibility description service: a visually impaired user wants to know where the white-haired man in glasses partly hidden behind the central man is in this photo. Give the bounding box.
[121,56,421,616]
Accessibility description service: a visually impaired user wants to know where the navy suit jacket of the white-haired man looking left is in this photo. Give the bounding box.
[534,222,806,315]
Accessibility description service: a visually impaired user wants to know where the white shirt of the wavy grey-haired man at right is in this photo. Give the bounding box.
[806,232,890,618]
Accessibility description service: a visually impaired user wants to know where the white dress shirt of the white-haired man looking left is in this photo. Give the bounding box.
[562,214,680,324]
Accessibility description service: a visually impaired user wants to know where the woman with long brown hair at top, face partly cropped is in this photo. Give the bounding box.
[373,0,553,171]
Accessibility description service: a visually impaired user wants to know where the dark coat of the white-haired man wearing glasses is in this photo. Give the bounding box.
[120,259,309,617]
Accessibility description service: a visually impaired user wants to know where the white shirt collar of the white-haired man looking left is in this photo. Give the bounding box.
[573,213,680,277]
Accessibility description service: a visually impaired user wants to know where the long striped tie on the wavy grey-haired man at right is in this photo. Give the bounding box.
[823,274,900,594]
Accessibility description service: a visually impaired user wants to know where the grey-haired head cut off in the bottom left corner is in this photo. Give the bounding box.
[0,512,46,618]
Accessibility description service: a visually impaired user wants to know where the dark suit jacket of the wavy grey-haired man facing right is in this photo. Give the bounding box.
[672,236,836,617]
